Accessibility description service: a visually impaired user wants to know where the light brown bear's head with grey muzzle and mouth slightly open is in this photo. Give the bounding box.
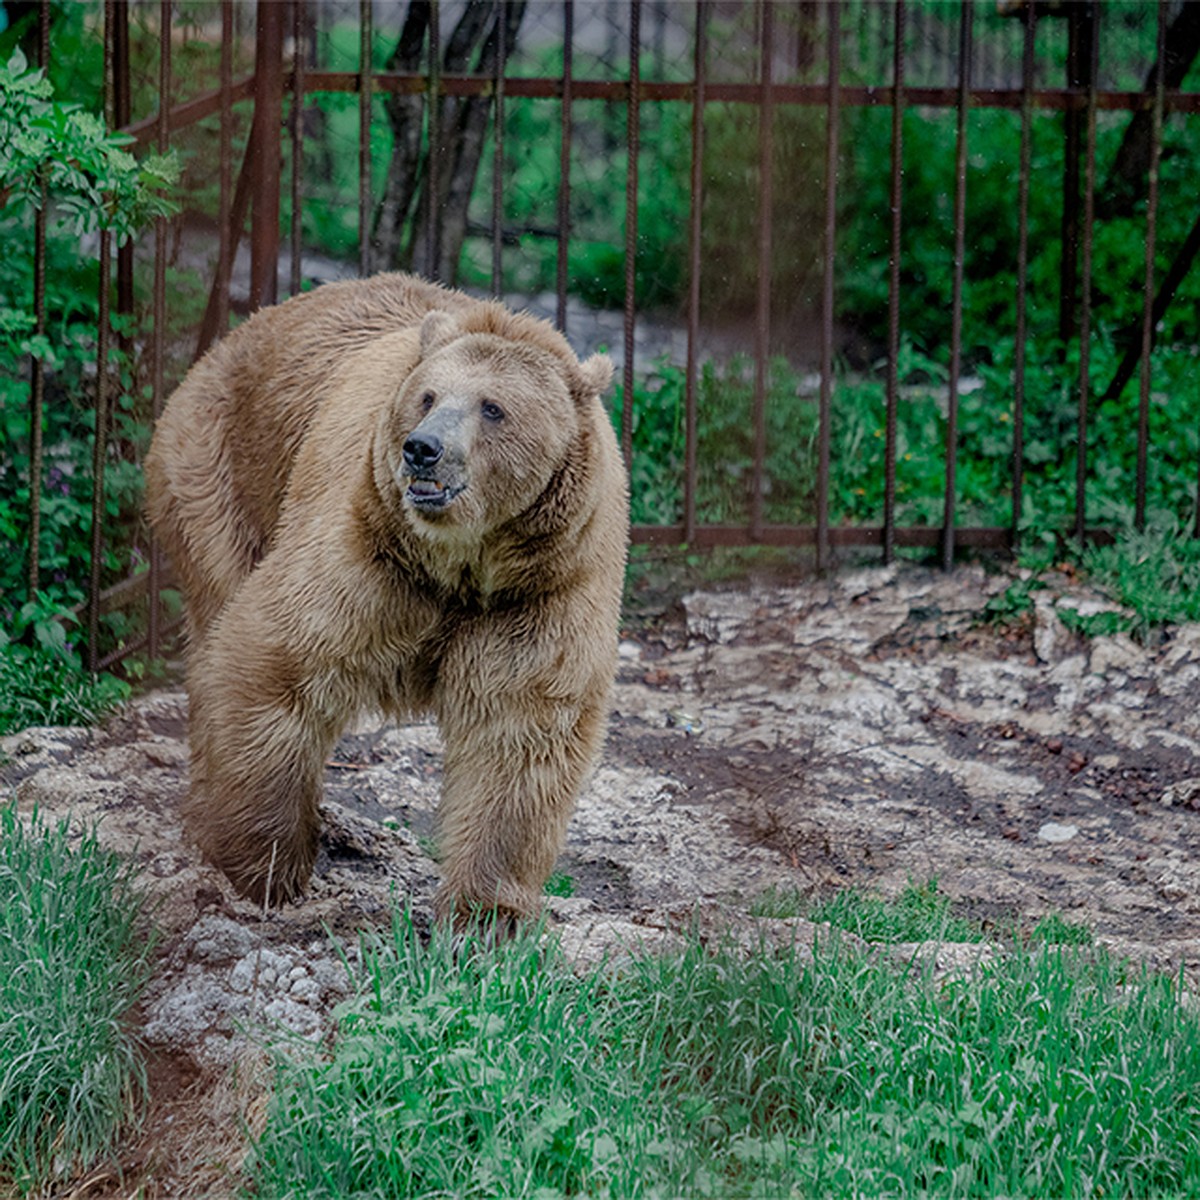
[382,304,612,540]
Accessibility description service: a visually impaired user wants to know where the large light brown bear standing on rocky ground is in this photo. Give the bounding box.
[146,274,629,920]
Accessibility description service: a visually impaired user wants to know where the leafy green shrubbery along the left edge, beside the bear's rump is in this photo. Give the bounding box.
[0,50,178,676]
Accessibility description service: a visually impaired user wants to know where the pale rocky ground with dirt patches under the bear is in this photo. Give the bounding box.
[0,568,1200,1195]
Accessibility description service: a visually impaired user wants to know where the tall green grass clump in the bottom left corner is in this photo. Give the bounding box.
[0,804,149,1195]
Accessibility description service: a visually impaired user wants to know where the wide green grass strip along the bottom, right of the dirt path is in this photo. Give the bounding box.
[251,902,1200,1200]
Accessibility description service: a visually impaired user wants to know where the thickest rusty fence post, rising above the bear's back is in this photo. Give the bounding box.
[247,4,287,310]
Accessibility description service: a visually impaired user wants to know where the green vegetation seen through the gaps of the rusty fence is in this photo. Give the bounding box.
[0,0,1200,681]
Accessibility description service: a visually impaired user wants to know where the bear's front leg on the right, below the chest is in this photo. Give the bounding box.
[436,679,607,925]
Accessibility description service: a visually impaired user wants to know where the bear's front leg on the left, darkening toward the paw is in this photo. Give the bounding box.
[184,620,337,904]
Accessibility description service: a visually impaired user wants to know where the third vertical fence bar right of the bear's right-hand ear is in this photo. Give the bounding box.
[750,0,775,541]
